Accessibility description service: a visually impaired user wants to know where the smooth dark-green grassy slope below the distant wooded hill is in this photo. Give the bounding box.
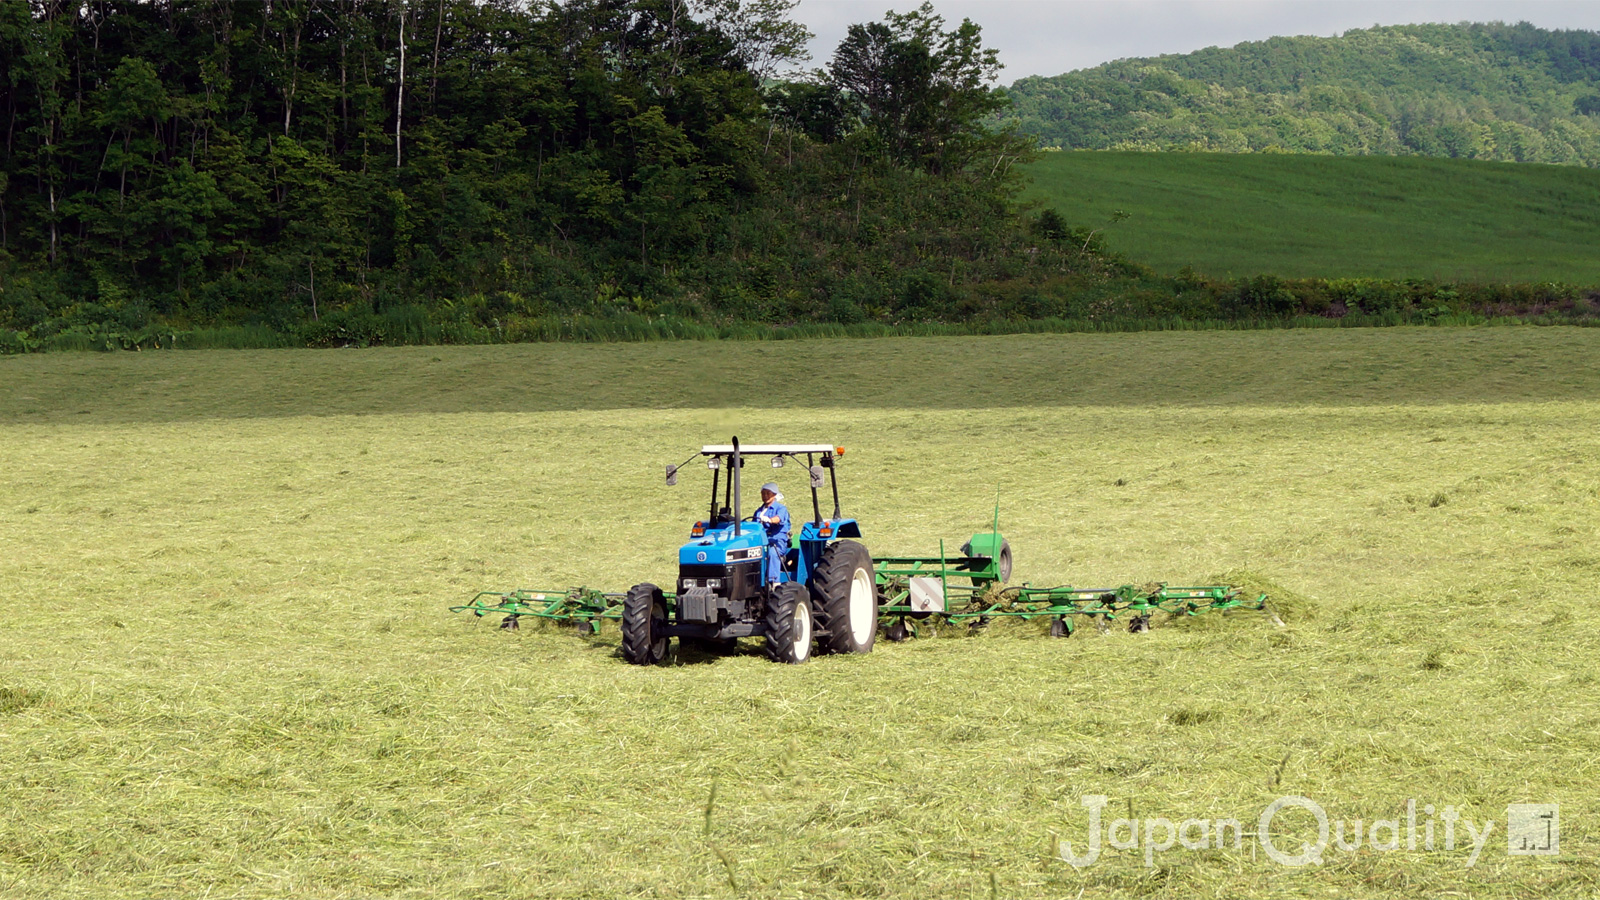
[1027,152,1600,285]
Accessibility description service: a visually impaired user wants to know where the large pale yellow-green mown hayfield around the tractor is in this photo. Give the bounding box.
[0,327,1600,900]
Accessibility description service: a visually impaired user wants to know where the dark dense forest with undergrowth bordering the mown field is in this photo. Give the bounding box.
[0,7,1589,352]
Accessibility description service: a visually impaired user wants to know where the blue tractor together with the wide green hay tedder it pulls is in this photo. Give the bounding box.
[451,439,1275,665]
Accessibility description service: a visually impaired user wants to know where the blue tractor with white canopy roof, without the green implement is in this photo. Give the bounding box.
[622,437,878,666]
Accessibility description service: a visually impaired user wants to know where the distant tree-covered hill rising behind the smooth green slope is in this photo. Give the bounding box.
[1011,22,1600,167]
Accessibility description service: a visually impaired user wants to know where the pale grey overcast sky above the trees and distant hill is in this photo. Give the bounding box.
[794,0,1600,85]
